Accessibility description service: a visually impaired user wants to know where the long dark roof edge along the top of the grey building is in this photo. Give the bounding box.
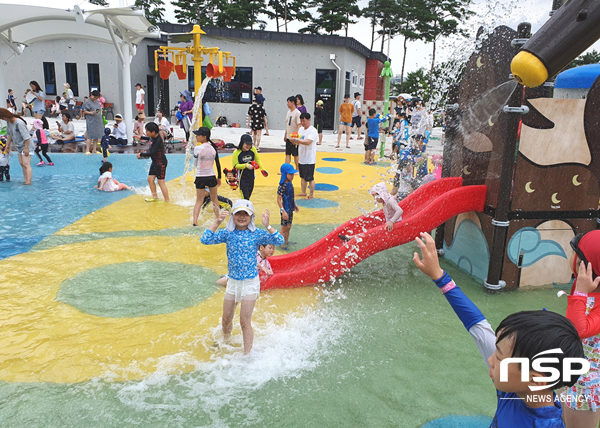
[159,23,388,62]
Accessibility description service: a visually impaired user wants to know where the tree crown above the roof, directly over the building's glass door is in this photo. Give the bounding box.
[299,0,361,37]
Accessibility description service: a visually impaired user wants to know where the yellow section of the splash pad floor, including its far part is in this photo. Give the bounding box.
[0,153,392,383]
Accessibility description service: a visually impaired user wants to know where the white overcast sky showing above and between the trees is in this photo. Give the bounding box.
[5,0,600,74]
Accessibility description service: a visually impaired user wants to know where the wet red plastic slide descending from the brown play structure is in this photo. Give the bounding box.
[261,177,487,290]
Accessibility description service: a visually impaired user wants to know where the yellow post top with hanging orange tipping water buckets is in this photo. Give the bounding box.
[154,25,235,95]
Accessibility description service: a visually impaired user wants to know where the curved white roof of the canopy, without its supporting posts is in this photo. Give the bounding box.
[0,3,159,51]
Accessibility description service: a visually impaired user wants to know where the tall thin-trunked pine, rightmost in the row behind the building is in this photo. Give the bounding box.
[422,0,475,88]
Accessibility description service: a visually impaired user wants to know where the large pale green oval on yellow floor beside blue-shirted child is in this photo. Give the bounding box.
[56,261,220,318]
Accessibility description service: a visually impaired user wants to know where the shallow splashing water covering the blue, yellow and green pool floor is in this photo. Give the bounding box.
[0,155,566,428]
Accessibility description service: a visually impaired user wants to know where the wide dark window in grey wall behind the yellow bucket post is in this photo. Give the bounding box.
[188,67,253,104]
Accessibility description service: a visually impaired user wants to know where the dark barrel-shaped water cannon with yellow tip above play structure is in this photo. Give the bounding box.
[510,0,600,88]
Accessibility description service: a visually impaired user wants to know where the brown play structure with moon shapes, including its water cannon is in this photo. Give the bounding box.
[436,0,600,289]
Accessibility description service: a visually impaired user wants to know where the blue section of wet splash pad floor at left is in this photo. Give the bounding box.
[0,153,185,259]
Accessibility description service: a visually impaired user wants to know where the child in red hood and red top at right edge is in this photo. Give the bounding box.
[563,230,600,428]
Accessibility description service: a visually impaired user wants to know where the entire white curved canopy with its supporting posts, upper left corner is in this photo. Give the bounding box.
[0,3,160,139]
